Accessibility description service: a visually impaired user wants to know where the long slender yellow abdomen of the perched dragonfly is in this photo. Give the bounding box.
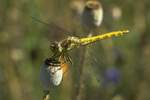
[80,30,129,45]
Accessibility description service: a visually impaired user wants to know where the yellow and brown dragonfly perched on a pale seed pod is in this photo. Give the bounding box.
[50,30,129,64]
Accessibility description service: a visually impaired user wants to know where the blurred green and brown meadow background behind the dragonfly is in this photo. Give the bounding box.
[0,0,150,100]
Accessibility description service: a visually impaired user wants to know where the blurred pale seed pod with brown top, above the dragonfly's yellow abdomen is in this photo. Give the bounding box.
[81,1,103,29]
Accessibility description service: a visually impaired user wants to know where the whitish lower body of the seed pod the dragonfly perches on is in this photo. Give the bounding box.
[40,62,63,90]
